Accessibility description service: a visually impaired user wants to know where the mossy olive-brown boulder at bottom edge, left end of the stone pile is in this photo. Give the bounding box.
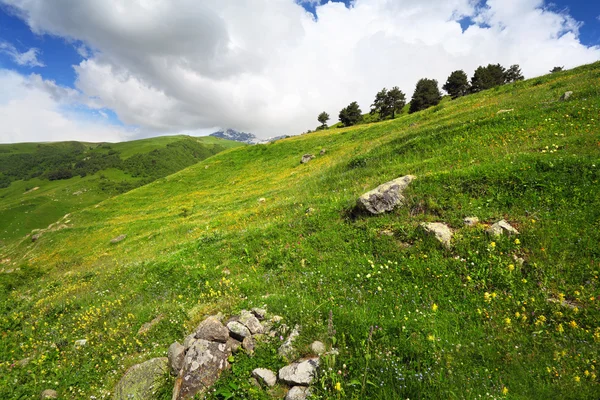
[113,357,169,400]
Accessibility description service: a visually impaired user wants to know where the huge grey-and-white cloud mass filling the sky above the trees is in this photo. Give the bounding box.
[0,0,600,141]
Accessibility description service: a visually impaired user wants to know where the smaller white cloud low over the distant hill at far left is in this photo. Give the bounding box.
[0,69,136,143]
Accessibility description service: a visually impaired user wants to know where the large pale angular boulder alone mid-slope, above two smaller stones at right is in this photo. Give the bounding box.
[357,175,415,215]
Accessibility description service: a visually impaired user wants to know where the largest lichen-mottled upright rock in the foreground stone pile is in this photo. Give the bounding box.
[173,339,231,400]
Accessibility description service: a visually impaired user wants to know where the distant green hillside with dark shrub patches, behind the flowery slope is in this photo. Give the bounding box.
[0,136,241,244]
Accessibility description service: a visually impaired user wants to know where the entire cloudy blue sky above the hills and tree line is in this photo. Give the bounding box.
[0,0,600,143]
